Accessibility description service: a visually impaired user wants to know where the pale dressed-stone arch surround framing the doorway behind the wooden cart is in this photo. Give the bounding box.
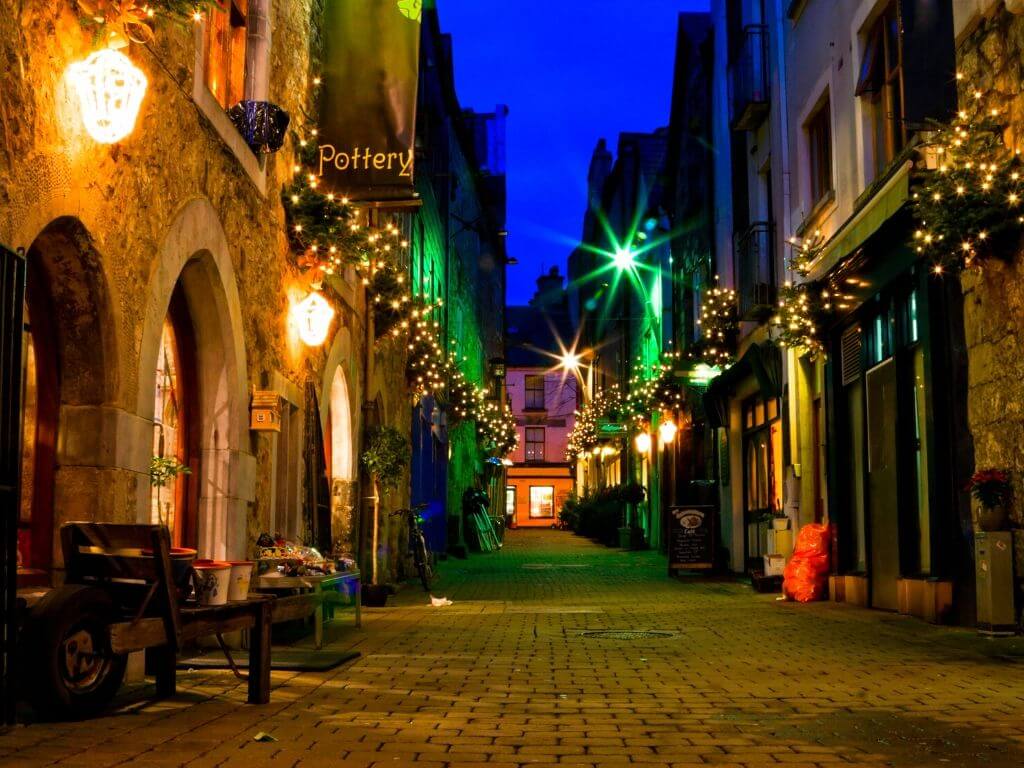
[136,199,256,559]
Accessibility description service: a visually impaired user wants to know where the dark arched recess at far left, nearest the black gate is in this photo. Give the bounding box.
[23,216,122,568]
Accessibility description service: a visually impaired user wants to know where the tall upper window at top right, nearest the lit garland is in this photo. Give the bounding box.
[856,2,906,178]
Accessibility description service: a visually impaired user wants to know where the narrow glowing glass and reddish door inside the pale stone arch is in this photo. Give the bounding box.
[150,284,201,548]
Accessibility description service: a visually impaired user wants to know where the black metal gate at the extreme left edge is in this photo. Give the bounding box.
[0,246,25,723]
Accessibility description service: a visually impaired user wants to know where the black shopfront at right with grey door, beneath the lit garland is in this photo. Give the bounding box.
[825,214,973,617]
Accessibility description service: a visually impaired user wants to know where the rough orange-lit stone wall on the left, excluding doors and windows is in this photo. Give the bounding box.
[0,0,409,572]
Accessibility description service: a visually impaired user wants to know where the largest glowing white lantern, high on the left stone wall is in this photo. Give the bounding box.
[68,48,146,144]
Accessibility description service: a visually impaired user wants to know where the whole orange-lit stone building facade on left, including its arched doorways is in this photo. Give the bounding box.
[0,0,409,577]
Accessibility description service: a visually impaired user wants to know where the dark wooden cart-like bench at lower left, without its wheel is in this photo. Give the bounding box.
[60,522,303,703]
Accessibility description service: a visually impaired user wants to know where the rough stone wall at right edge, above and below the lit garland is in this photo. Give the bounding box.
[957,4,1024,517]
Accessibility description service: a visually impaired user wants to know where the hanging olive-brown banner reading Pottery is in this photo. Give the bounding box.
[316,0,422,201]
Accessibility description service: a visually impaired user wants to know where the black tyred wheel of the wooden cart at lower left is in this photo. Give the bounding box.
[23,585,127,720]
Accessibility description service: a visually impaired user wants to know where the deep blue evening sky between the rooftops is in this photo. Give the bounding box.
[437,0,708,304]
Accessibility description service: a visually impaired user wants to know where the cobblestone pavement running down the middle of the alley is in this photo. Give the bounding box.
[6,531,1024,768]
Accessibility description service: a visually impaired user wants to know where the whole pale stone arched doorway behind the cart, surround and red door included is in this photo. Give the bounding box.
[135,199,256,560]
